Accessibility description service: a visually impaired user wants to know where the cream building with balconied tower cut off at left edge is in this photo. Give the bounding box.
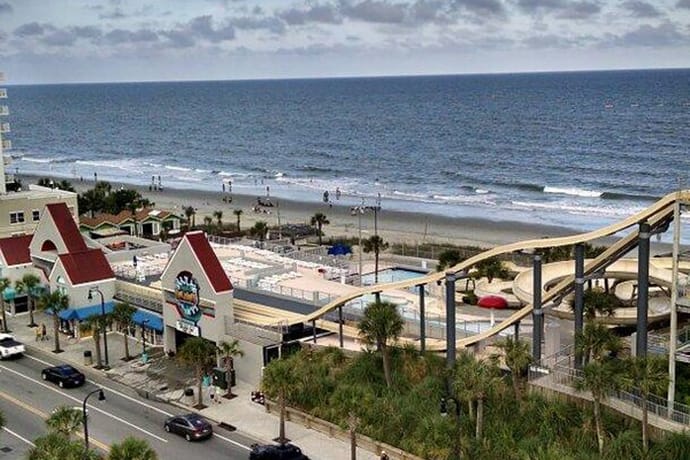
[0,73,79,238]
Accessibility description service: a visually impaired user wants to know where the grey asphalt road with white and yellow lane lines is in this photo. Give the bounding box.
[0,355,257,460]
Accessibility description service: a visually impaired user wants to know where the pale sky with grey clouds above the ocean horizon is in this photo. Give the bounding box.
[0,0,690,84]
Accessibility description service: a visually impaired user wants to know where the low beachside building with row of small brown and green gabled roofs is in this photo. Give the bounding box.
[79,208,182,239]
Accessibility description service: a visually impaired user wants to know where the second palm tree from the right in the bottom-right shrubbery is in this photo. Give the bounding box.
[575,360,621,455]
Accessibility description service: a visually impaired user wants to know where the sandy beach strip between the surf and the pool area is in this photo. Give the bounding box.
[21,175,606,248]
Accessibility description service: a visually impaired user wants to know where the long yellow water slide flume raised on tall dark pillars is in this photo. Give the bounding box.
[255,190,690,351]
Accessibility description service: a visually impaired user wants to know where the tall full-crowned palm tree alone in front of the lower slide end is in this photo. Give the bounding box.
[359,302,404,388]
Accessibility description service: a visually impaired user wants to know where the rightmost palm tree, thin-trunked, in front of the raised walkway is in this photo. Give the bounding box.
[625,356,669,453]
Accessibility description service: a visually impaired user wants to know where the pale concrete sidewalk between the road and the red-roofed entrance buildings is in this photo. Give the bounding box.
[7,312,379,460]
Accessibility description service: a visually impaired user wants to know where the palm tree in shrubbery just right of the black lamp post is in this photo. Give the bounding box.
[452,353,501,440]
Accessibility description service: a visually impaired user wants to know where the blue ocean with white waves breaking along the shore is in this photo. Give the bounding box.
[7,69,690,239]
